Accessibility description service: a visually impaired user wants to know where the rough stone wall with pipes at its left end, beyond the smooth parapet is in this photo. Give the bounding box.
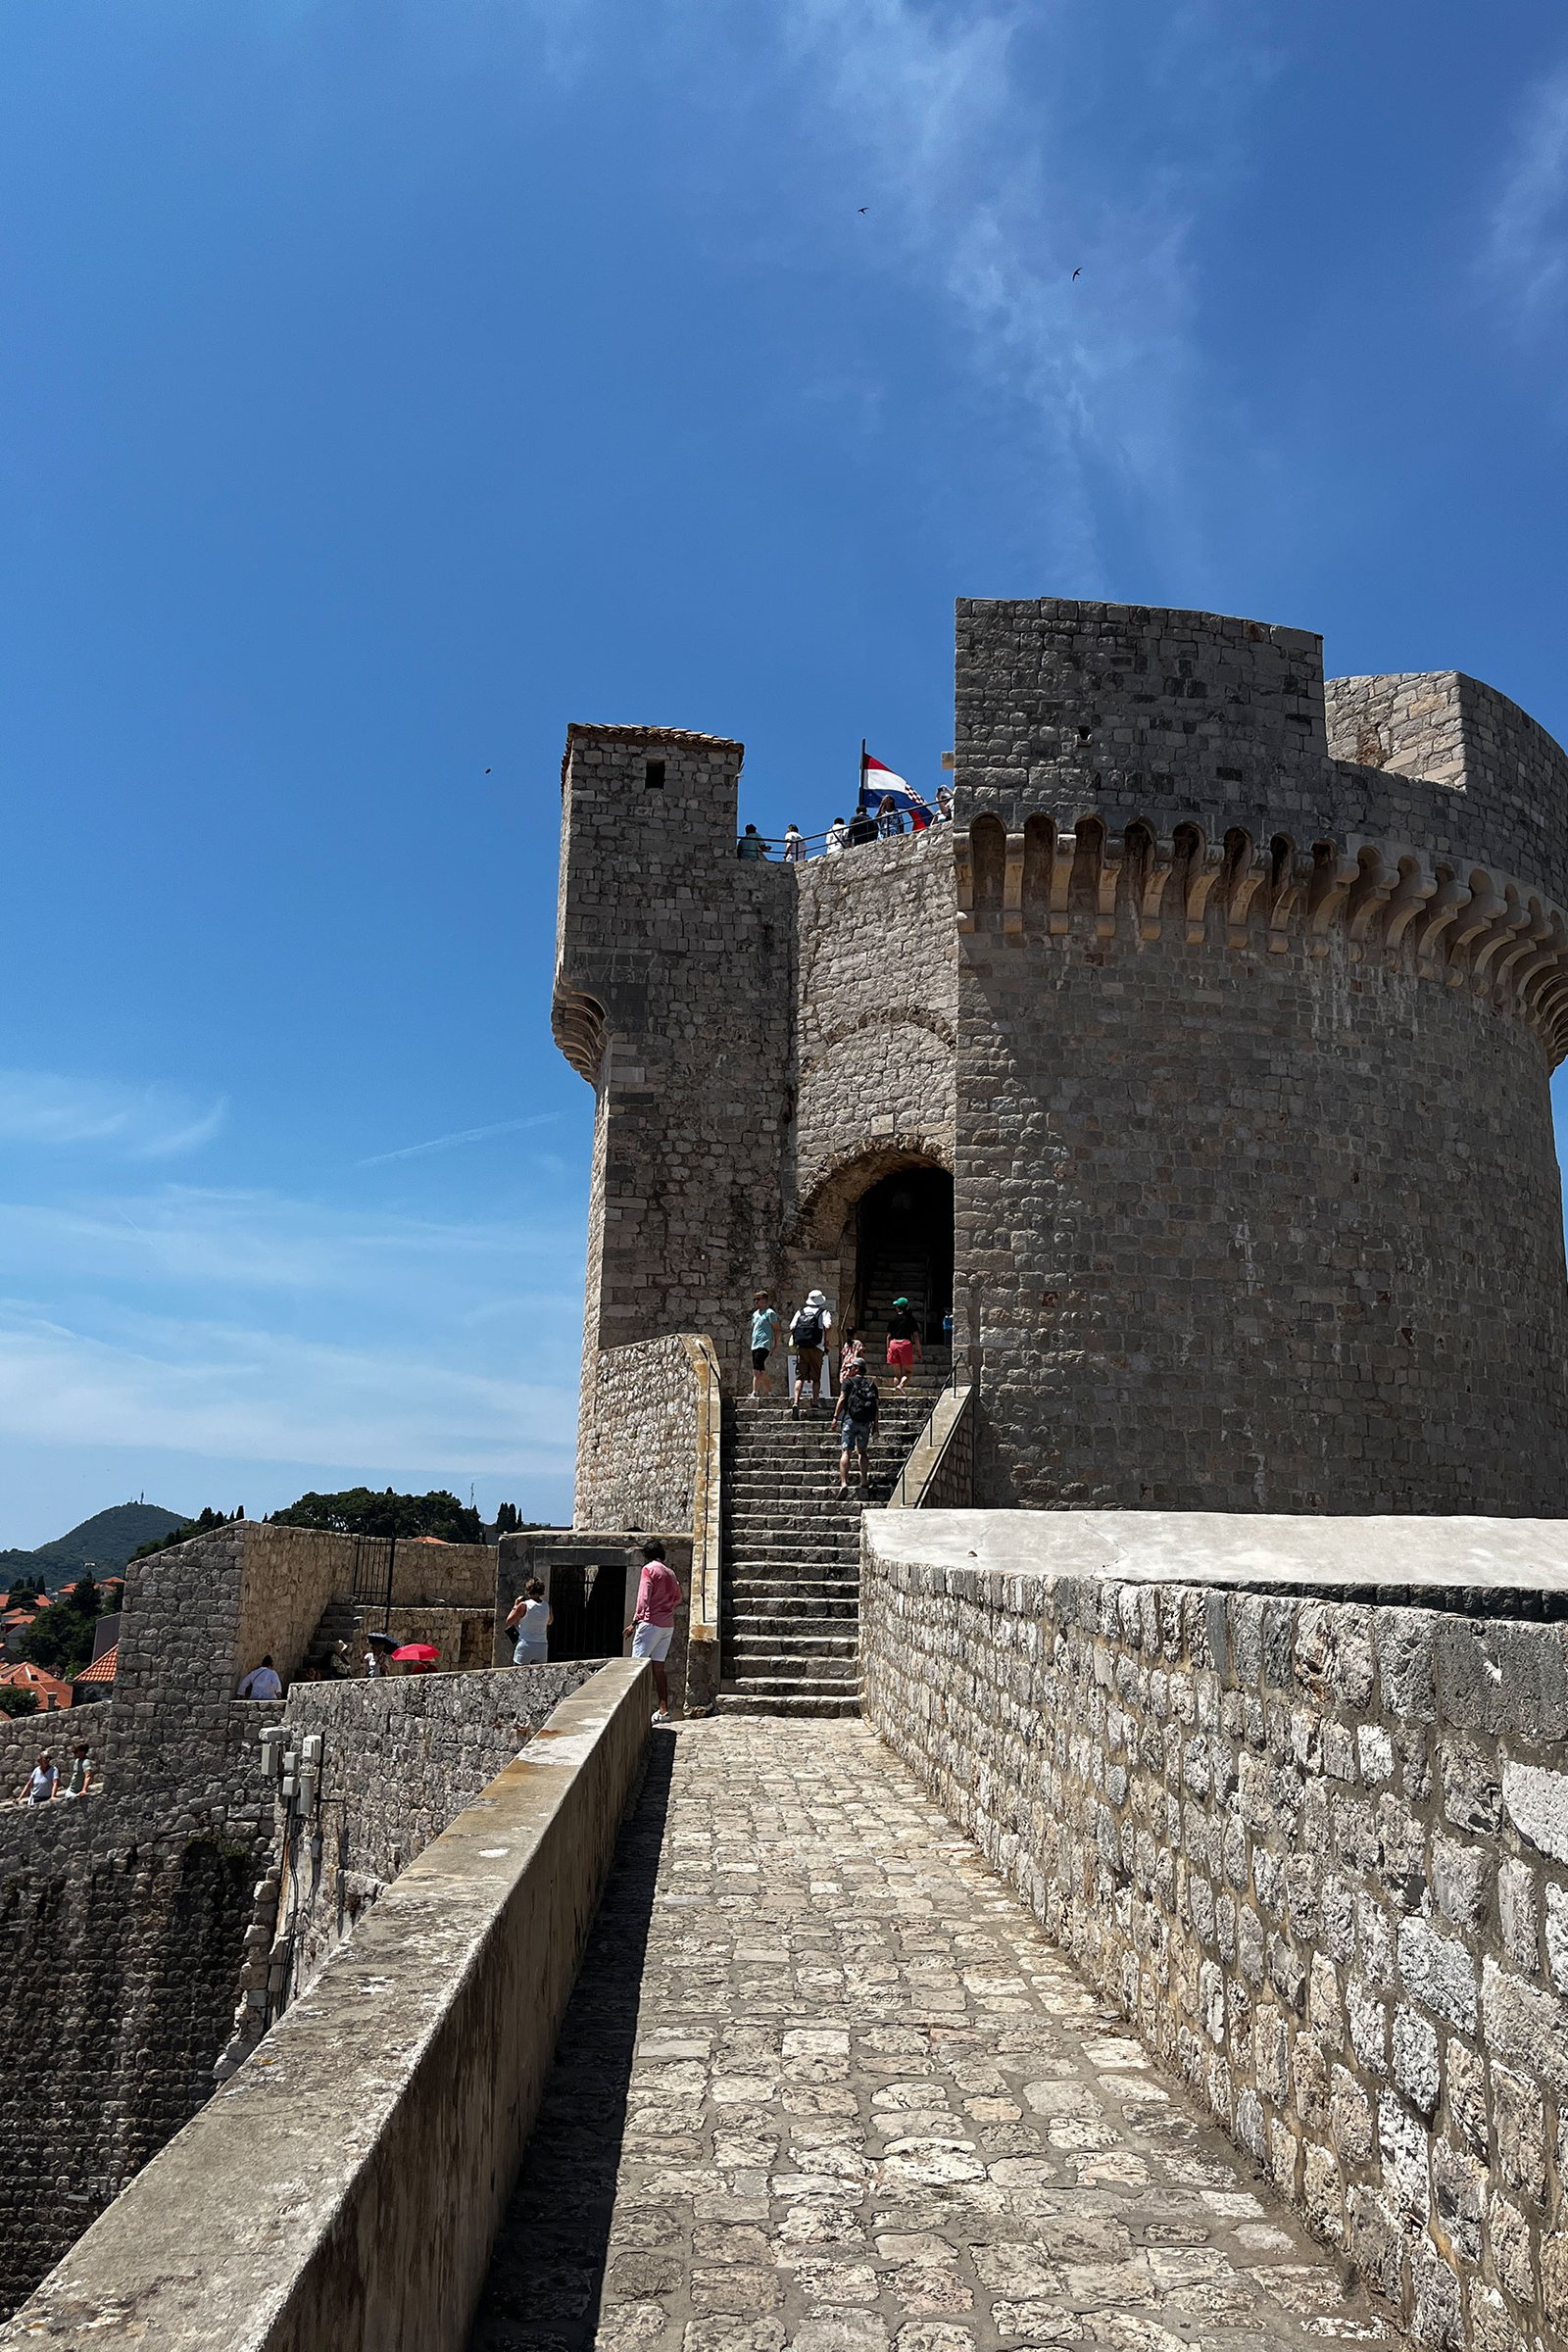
[268,1655,597,2009]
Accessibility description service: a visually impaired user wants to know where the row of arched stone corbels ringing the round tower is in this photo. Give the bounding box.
[953,811,1568,1068]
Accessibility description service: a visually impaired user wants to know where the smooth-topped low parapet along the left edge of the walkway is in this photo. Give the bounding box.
[0,1663,649,2352]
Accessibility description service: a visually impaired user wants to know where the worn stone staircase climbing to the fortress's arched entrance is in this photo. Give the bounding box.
[717,1350,948,1715]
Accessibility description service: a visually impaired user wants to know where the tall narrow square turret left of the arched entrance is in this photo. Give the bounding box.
[555,727,795,1433]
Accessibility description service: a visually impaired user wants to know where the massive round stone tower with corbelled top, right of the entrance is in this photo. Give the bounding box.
[955,600,1568,1515]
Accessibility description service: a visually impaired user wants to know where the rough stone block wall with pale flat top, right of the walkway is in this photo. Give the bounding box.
[860,1512,1568,2352]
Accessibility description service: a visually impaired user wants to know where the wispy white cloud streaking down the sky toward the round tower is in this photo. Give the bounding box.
[514,0,1279,593]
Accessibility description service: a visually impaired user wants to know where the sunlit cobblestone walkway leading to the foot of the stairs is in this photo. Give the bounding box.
[472,1717,1394,2352]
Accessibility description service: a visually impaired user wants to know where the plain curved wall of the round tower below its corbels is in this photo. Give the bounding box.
[956,924,1568,1517]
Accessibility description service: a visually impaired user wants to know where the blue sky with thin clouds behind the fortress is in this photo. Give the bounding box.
[0,0,1568,1543]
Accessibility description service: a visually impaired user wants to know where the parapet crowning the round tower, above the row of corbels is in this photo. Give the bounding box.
[955,598,1568,904]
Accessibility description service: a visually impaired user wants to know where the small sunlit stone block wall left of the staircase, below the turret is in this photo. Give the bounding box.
[571,1334,717,1529]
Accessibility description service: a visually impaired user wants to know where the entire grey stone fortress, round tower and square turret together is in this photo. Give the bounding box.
[558,600,1568,1515]
